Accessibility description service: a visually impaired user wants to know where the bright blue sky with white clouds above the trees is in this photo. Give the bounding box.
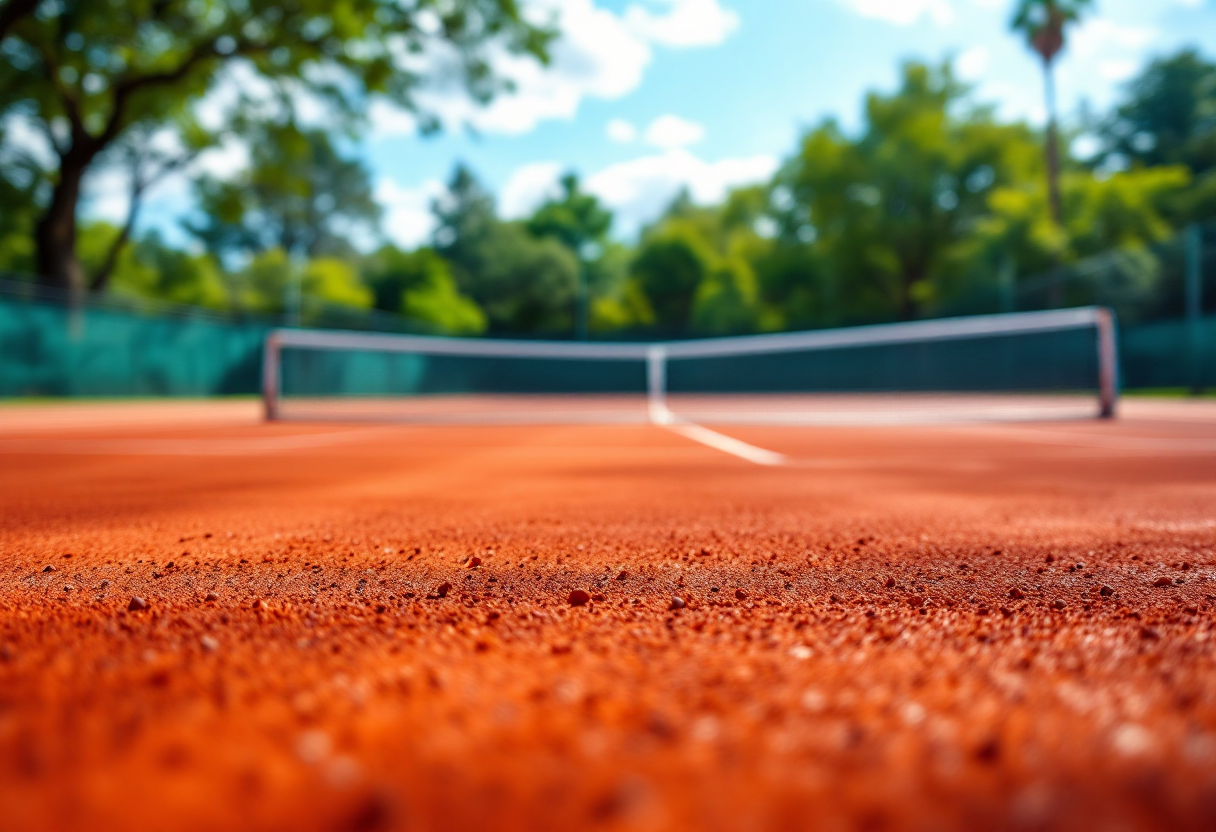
[102,0,1216,246]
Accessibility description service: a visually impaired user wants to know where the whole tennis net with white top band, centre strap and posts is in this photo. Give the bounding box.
[263,308,1118,425]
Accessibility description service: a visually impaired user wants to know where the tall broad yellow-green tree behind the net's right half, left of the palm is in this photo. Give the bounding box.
[775,63,1041,324]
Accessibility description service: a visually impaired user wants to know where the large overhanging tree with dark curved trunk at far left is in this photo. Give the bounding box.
[0,0,551,293]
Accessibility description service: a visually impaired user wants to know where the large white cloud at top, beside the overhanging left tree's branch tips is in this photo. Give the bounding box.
[371,0,738,136]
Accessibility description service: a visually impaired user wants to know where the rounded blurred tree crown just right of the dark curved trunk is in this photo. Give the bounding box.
[186,122,381,259]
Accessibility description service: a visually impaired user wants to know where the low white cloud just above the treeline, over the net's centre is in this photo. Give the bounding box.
[584,148,778,236]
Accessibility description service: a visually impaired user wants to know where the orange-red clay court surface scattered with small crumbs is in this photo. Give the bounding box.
[0,400,1216,831]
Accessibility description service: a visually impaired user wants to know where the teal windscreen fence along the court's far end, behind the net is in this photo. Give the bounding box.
[0,293,1216,398]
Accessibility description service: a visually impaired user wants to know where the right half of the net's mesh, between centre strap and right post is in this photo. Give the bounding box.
[666,327,1099,425]
